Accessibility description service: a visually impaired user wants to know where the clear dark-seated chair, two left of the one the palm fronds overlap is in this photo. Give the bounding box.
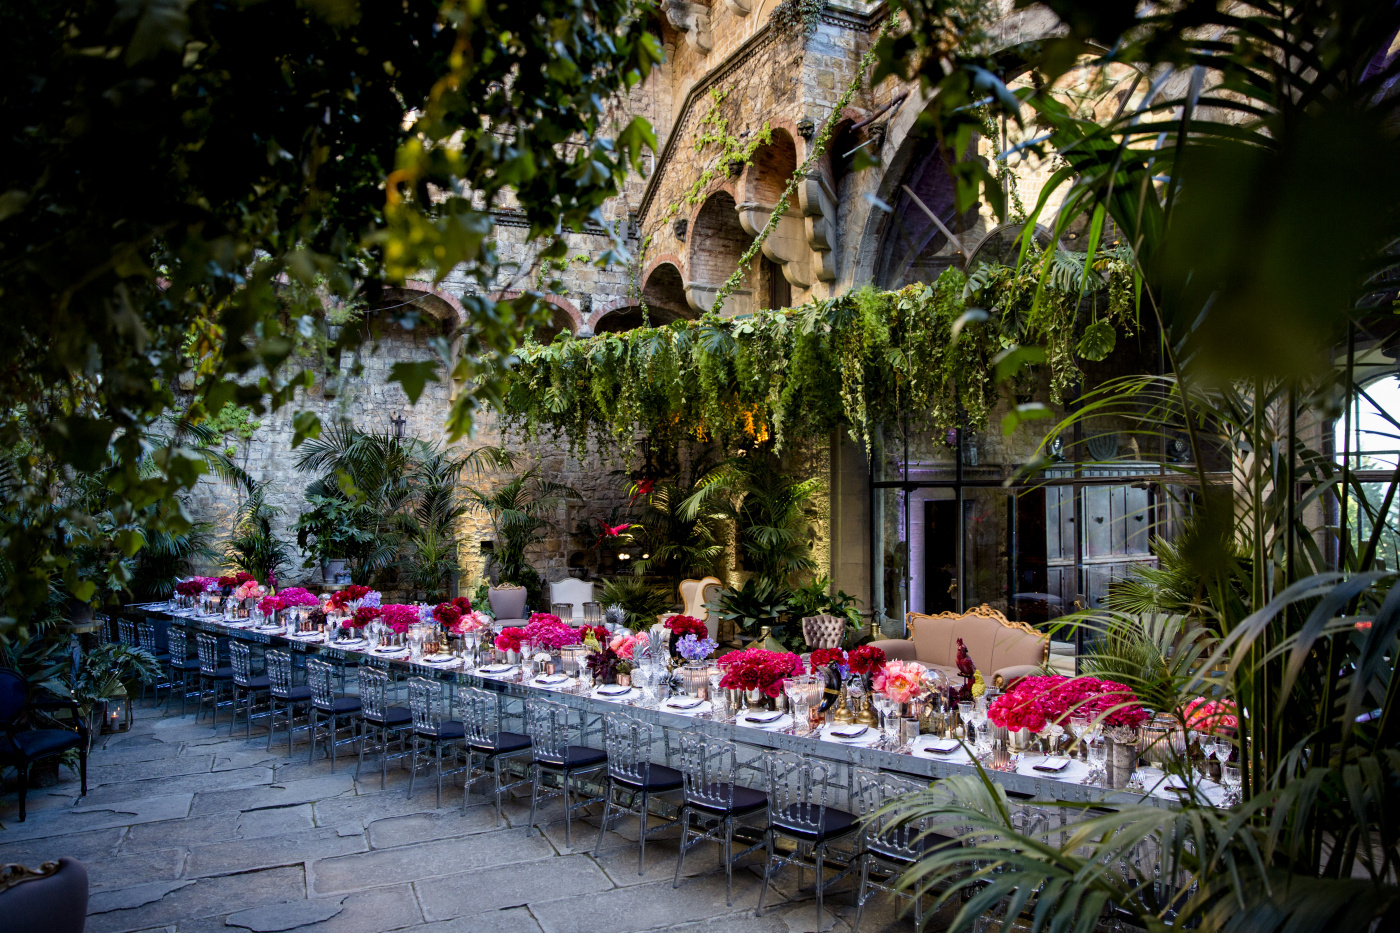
[671,731,769,906]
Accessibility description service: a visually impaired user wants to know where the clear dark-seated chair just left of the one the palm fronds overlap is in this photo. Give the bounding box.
[753,751,858,926]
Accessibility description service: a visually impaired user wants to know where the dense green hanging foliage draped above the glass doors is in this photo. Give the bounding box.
[505,251,1137,452]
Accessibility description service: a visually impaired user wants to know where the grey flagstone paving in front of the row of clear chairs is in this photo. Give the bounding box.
[0,705,949,933]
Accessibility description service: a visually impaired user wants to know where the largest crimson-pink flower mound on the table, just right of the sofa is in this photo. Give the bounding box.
[987,675,1147,733]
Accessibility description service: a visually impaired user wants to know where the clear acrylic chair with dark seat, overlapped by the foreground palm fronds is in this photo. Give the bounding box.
[853,768,963,933]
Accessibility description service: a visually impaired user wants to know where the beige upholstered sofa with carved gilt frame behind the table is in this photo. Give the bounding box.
[871,605,1050,686]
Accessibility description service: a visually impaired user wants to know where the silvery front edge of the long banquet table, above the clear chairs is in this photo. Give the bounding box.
[125,602,1222,808]
